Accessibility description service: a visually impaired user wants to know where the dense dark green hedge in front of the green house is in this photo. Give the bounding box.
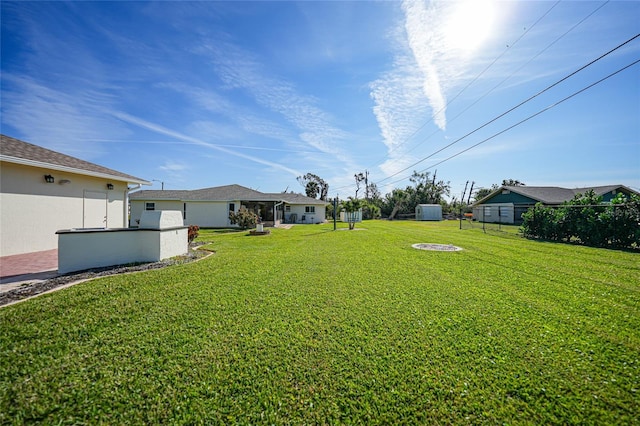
[522,191,640,249]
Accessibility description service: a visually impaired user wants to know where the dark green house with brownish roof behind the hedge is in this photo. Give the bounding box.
[473,185,640,225]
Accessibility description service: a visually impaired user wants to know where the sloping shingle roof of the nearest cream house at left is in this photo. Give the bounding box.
[0,135,151,185]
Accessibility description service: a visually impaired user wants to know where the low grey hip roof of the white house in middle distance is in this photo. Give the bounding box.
[129,184,328,205]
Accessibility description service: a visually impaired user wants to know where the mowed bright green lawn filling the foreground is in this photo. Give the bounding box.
[0,221,640,424]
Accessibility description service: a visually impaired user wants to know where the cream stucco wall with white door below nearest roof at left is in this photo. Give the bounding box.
[0,162,127,256]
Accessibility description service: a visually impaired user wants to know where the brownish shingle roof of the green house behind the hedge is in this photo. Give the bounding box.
[474,185,638,205]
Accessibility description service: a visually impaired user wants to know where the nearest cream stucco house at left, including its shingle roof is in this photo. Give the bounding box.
[0,135,151,256]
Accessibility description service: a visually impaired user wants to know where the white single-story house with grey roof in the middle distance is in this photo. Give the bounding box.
[130,185,328,228]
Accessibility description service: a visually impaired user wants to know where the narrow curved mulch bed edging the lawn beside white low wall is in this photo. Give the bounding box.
[0,245,212,306]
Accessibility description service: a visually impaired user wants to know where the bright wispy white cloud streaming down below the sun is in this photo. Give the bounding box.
[370,0,488,176]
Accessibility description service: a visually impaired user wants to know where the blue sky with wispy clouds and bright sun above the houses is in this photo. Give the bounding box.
[1,1,640,198]
